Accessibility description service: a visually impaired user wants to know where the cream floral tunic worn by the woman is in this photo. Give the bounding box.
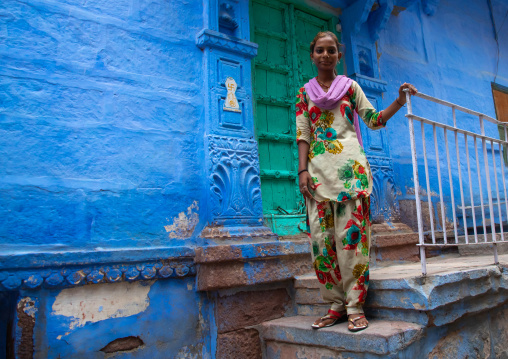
[296,81,385,202]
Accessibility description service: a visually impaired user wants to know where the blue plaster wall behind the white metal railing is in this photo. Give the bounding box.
[377,0,508,226]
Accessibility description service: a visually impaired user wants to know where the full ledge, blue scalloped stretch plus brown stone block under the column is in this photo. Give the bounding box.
[0,241,311,291]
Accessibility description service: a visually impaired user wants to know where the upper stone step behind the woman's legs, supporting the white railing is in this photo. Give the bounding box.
[294,255,508,325]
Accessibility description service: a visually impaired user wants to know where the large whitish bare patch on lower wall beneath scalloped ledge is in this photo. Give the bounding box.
[52,282,153,330]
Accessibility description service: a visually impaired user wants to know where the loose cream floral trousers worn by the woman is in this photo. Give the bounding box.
[307,197,371,315]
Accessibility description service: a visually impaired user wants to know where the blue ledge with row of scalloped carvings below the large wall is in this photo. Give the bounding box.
[0,247,196,290]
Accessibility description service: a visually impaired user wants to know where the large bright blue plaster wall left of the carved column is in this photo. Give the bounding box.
[0,0,204,253]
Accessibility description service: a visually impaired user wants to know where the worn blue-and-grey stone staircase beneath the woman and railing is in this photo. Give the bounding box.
[255,255,508,359]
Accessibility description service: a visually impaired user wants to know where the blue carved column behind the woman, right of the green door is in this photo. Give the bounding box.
[341,0,400,223]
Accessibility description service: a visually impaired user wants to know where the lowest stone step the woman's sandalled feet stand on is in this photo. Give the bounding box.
[255,316,423,359]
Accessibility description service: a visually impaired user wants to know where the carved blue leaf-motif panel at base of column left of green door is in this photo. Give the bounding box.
[208,135,262,225]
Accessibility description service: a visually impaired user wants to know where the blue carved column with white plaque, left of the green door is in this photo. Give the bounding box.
[196,0,273,239]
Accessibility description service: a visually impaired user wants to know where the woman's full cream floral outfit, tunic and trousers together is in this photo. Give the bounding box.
[296,81,384,315]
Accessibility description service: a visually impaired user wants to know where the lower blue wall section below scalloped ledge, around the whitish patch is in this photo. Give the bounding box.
[26,277,211,359]
